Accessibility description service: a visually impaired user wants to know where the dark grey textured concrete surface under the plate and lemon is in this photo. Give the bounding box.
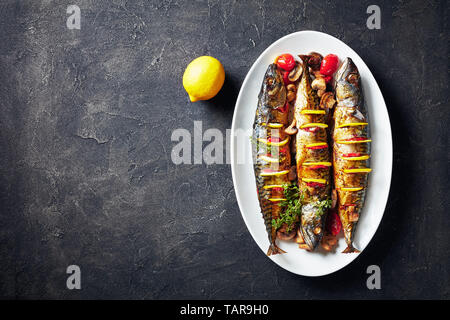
[0,0,450,299]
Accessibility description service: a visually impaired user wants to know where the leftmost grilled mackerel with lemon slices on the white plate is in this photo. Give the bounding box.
[253,64,291,256]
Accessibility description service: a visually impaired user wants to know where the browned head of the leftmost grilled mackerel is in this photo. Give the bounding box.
[260,63,286,109]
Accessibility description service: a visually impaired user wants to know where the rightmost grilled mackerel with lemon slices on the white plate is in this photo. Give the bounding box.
[333,58,371,253]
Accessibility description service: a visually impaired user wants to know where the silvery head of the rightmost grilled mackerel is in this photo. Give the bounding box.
[334,58,361,107]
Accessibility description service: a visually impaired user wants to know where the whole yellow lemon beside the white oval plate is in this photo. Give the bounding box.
[183,56,225,102]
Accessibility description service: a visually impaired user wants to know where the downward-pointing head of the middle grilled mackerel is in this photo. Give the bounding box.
[300,203,324,251]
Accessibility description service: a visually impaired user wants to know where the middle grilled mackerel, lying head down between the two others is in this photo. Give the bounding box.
[295,58,331,251]
